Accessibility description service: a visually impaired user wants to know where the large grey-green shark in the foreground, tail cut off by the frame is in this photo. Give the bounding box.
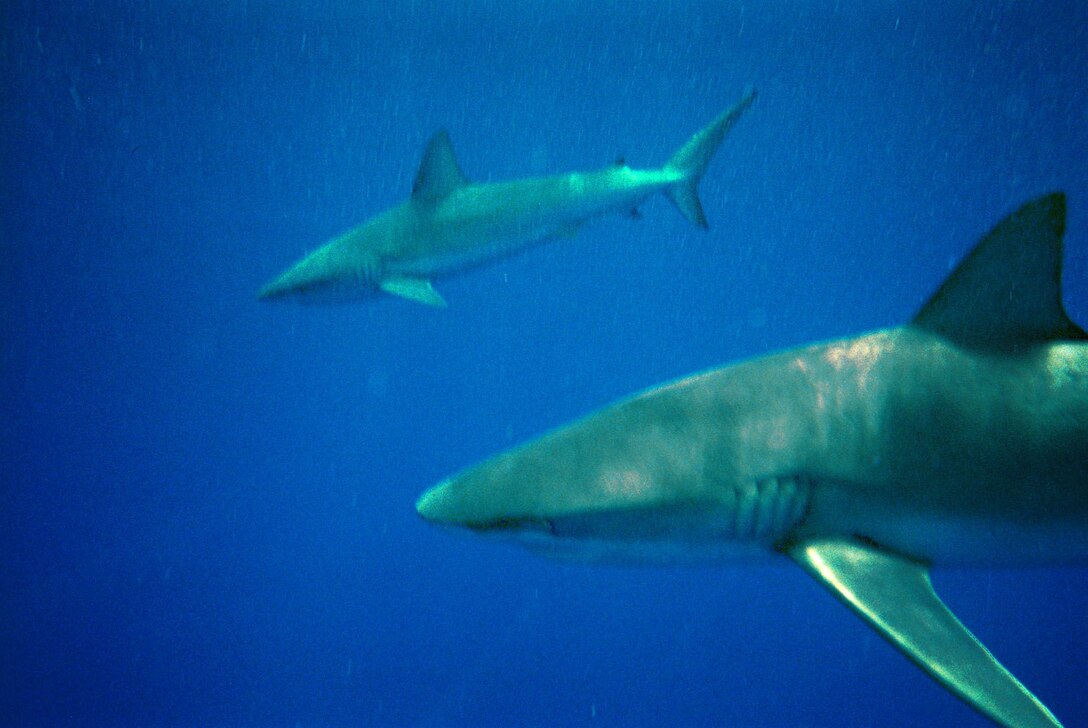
[417,194,1088,727]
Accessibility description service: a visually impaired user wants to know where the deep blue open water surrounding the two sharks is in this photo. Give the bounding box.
[0,0,1088,726]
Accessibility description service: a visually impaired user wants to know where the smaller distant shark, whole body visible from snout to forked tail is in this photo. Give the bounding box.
[259,89,755,307]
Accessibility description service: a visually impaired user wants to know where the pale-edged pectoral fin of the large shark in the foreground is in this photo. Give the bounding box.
[789,539,1061,728]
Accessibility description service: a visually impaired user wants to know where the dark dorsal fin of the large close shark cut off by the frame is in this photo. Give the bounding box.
[911,193,1088,350]
